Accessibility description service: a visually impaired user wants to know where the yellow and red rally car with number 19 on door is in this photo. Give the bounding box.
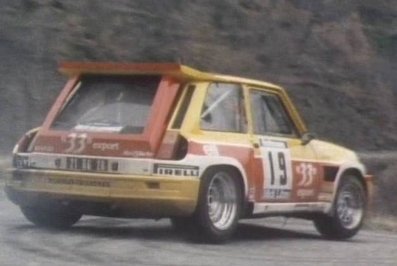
[5,62,372,242]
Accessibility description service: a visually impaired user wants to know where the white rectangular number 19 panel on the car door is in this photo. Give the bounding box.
[260,139,292,200]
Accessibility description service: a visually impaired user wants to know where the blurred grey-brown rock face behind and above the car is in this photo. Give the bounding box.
[0,0,397,151]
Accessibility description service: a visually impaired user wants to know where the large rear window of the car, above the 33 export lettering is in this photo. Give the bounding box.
[51,75,161,134]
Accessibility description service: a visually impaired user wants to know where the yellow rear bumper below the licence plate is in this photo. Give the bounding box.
[5,169,199,217]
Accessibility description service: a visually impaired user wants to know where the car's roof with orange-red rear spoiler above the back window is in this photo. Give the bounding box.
[59,62,282,90]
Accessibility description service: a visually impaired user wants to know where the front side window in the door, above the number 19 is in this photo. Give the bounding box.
[250,90,296,135]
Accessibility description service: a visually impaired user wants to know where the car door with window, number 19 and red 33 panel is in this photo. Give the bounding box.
[248,88,322,202]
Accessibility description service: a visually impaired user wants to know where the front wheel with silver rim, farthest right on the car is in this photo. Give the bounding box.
[314,176,367,240]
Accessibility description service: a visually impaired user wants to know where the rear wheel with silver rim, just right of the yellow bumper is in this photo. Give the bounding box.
[190,167,242,244]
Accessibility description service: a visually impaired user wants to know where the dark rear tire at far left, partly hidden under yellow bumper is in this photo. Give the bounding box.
[21,206,82,229]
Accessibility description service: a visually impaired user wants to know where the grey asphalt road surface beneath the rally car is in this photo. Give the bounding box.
[0,185,397,266]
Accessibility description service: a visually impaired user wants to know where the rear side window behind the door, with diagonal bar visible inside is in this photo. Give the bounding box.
[201,83,247,132]
